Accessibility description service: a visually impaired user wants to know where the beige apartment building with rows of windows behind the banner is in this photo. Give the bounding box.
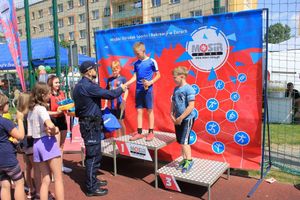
[17,0,257,57]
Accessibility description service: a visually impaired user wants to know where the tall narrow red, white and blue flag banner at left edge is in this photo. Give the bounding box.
[0,0,26,91]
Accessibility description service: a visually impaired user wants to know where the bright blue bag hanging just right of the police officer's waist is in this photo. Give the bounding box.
[102,108,121,132]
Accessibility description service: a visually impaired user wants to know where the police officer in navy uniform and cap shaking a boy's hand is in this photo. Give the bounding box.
[73,61,127,196]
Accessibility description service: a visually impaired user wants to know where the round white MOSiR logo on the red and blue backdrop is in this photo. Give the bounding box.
[186,26,229,71]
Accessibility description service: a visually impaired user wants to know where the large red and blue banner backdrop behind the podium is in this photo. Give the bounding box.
[95,10,263,169]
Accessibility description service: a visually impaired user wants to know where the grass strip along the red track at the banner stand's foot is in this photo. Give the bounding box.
[230,167,300,185]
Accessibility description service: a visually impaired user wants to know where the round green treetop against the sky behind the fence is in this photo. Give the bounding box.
[265,23,291,44]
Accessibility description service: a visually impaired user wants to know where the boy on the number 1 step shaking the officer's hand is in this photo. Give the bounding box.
[125,42,160,141]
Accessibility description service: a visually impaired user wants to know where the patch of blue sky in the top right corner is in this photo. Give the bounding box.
[258,0,300,36]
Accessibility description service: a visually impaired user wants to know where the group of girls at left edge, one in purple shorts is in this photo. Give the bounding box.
[0,82,64,200]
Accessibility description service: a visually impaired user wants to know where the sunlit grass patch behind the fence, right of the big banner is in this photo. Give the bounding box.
[270,124,300,145]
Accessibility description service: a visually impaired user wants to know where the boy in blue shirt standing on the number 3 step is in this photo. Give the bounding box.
[171,67,195,173]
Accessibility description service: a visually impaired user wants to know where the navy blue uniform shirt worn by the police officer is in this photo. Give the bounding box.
[73,77,123,118]
